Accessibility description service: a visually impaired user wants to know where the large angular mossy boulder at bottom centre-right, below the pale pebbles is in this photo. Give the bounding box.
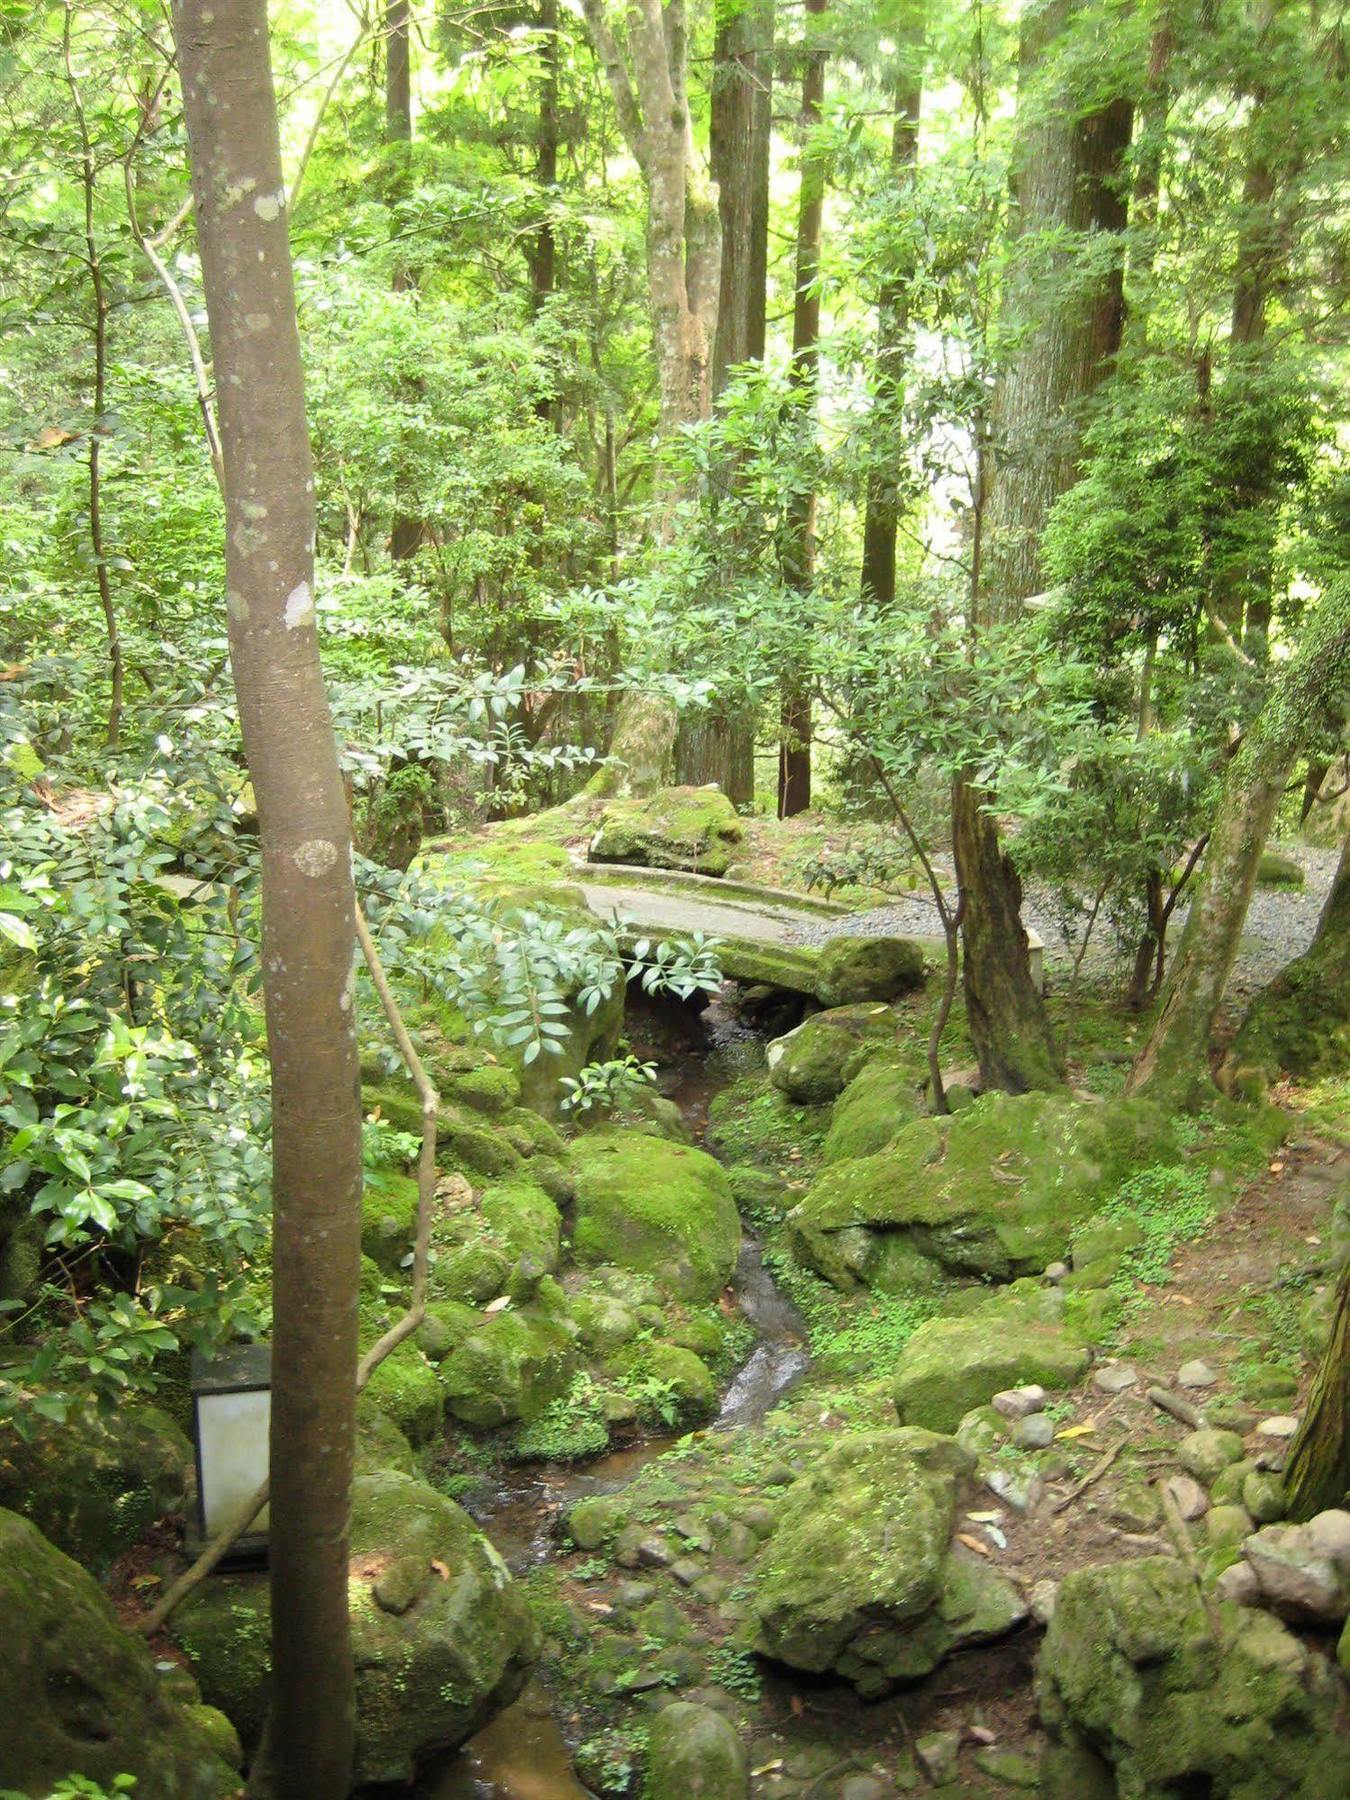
[752,1429,1026,1699]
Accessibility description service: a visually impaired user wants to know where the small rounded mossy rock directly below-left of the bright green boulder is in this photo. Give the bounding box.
[439,1305,578,1426]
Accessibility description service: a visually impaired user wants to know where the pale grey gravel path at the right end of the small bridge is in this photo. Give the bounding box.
[788,844,1339,994]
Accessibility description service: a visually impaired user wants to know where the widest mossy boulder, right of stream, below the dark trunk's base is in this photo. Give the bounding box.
[792,1087,1175,1280]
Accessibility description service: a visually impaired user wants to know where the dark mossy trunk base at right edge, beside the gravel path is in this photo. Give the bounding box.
[1220,824,1350,1089]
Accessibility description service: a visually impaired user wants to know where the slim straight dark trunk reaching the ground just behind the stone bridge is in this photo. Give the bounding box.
[778,0,828,819]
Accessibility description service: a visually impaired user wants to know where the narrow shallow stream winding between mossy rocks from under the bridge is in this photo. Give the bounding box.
[419,1001,810,1800]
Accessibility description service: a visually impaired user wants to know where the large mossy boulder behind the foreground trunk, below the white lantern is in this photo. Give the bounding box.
[173,1471,538,1782]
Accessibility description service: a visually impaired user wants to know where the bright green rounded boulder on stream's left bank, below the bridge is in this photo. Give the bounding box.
[572,1130,740,1301]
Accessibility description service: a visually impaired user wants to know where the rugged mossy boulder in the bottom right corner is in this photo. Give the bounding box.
[1037,1557,1345,1800]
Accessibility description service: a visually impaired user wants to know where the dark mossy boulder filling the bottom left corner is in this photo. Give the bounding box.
[0,1510,239,1800]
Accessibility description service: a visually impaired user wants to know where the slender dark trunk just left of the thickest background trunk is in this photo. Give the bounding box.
[862,49,923,607]
